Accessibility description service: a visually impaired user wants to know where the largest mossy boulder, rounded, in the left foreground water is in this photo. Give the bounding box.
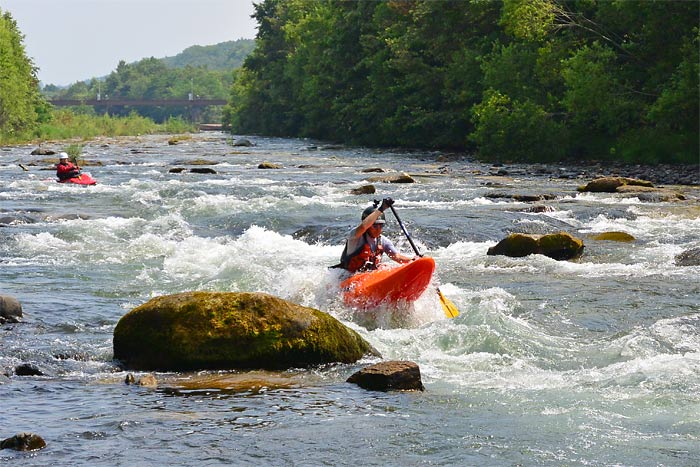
[113,292,378,371]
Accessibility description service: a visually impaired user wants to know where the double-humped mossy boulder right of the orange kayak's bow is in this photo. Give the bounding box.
[487,232,584,260]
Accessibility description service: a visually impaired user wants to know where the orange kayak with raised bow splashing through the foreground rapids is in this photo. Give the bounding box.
[340,257,435,309]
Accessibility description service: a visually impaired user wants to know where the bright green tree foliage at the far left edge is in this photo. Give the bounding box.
[0,10,49,141]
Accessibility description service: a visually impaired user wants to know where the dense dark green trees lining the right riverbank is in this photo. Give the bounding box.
[225,0,700,163]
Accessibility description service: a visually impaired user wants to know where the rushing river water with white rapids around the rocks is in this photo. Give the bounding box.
[0,133,700,466]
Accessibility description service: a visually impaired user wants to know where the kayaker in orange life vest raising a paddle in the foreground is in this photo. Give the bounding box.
[340,198,413,272]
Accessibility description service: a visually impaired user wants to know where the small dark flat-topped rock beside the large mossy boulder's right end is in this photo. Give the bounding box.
[347,361,425,391]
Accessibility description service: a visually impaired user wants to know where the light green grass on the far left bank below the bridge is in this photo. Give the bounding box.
[0,109,196,144]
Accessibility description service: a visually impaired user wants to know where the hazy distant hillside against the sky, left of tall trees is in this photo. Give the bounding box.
[161,39,255,70]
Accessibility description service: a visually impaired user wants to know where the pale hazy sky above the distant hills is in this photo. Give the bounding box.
[0,0,260,85]
